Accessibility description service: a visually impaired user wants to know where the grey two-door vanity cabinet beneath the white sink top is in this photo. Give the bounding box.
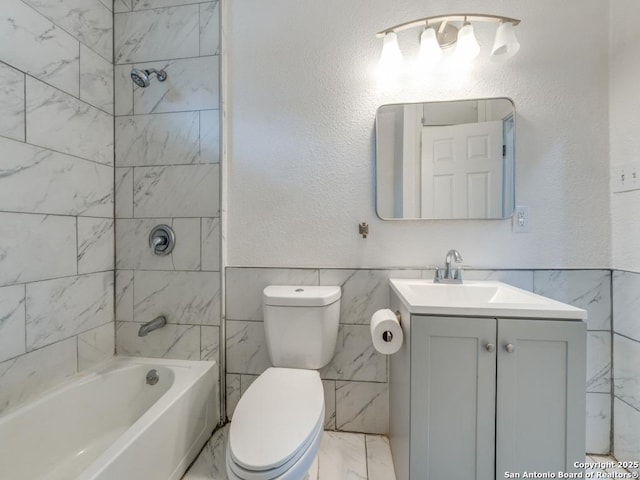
[390,303,586,480]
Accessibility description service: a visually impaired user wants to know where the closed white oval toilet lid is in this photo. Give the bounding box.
[229,368,324,471]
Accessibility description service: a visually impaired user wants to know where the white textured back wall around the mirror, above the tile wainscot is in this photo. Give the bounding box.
[225,0,611,268]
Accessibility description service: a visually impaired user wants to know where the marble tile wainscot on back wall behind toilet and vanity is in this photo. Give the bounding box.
[226,267,612,453]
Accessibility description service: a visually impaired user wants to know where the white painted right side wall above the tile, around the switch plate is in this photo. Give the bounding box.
[610,0,640,272]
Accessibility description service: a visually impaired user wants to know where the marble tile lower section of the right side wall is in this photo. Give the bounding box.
[613,271,640,472]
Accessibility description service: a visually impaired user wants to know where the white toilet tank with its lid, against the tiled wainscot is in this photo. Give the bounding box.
[262,285,341,370]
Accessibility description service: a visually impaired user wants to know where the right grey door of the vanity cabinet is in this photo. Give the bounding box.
[496,319,586,478]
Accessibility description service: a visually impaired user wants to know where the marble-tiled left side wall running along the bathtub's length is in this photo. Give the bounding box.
[0,0,115,411]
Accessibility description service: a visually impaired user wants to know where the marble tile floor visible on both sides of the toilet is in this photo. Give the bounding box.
[182,425,396,480]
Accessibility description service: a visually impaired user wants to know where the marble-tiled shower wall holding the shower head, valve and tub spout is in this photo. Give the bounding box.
[114,0,221,378]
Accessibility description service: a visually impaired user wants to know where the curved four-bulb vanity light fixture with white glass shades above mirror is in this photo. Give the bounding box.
[376,13,520,69]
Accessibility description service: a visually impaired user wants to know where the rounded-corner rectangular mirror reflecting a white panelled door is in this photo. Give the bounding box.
[376,98,515,220]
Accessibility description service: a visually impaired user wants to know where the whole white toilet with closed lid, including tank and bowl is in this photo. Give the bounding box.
[226,285,341,480]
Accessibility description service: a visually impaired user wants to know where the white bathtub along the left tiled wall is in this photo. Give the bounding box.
[0,357,218,480]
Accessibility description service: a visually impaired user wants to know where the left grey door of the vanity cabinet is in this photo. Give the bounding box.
[410,315,496,480]
